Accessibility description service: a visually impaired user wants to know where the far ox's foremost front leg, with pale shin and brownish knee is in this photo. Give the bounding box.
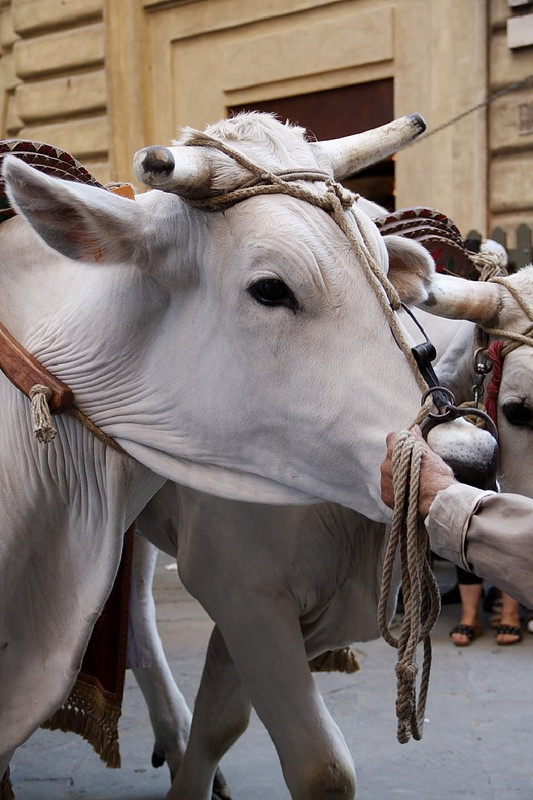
[200,594,355,800]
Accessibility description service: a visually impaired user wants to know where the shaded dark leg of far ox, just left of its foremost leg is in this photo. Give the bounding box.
[167,627,251,800]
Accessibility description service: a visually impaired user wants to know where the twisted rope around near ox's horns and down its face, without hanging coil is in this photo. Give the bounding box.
[182,131,428,392]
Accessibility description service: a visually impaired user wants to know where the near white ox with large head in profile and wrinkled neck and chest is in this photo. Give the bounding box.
[0,111,496,792]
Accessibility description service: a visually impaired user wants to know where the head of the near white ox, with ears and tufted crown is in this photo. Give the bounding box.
[2,115,488,518]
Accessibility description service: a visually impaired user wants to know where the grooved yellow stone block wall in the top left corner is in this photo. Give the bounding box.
[0,0,110,181]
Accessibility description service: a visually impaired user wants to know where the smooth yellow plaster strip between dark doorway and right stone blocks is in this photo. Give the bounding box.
[394,0,487,231]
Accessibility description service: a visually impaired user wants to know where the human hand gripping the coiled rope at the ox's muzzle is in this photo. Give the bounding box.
[381,425,457,519]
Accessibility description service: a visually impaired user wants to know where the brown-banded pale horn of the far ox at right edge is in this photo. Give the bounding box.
[417,275,502,325]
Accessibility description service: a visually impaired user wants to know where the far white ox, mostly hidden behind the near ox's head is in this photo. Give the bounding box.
[128,267,533,800]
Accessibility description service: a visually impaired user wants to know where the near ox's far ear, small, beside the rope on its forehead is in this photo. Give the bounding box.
[383,236,435,305]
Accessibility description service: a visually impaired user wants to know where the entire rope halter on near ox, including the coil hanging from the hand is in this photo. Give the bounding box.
[178,132,440,742]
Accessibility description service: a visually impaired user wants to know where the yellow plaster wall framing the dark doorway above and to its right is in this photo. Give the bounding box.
[138,0,487,233]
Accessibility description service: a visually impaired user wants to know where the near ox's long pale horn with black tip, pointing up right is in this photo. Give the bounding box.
[312,114,426,180]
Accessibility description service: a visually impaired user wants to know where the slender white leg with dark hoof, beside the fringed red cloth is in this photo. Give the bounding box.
[130,536,192,778]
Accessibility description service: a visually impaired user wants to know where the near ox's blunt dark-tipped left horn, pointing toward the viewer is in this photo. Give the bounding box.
[133,145,211,197]
